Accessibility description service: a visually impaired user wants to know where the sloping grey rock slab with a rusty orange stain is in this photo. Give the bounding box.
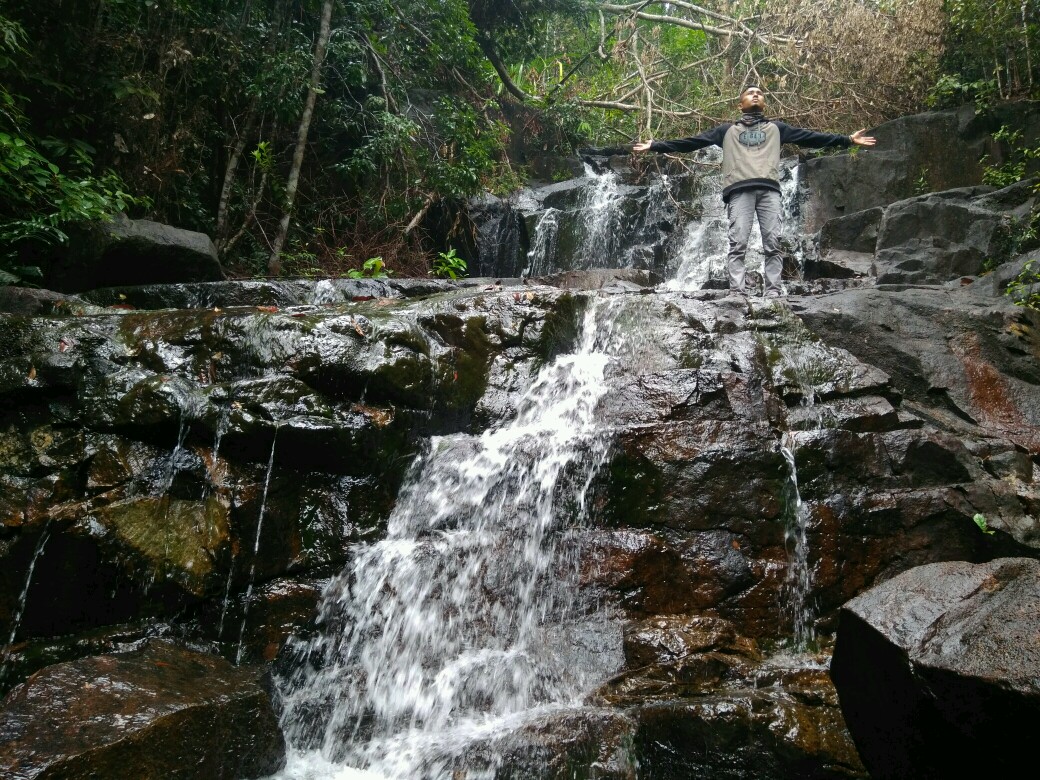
[792,282,1040,453]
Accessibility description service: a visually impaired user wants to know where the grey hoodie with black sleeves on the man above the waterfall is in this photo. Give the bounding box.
[650,118,853,202]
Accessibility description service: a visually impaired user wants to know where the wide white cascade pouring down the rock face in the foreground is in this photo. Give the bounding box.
[268,298,621,780]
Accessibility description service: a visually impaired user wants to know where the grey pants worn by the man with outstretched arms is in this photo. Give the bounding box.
[726,187,783,294]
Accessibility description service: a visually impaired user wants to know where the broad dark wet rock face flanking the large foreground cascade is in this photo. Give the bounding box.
[6,105,1040,779]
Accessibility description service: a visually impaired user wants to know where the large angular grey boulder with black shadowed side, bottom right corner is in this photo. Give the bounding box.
[831,558,1040,780]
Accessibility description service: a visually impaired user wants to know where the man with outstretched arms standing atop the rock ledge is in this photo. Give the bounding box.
[632,86,876,297]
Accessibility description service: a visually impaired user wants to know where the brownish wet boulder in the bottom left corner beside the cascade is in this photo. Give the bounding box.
[0,641,285,780]
